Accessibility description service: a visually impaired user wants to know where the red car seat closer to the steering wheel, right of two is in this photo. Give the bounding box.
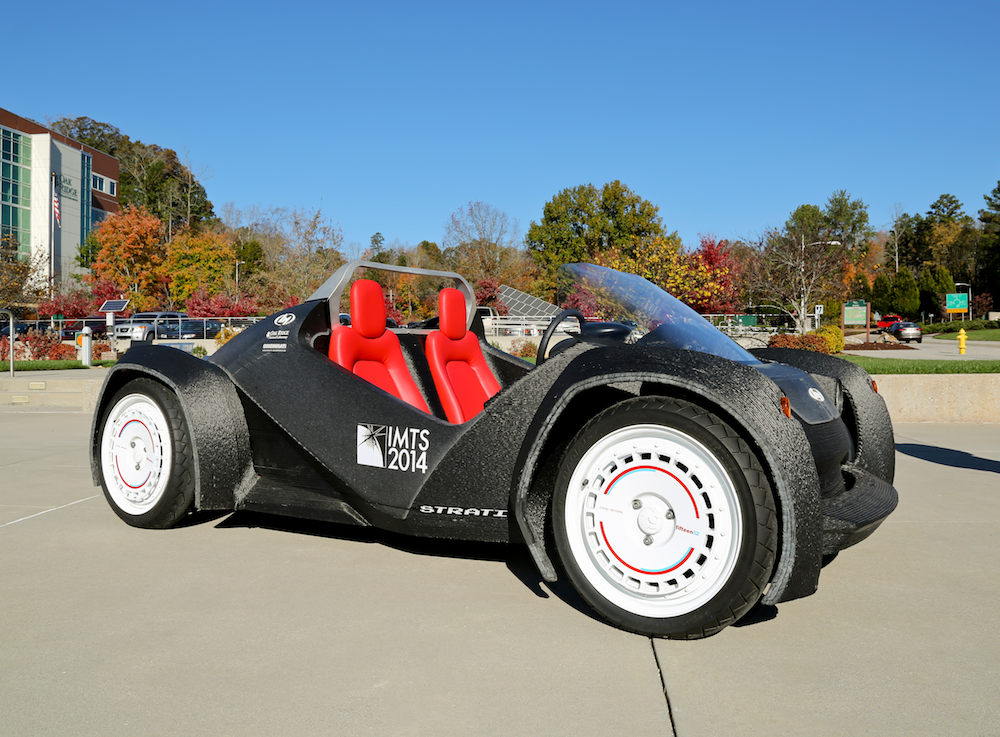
[426,289,500,424]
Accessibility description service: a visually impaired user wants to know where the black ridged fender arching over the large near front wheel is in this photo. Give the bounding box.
[511,344,822,604]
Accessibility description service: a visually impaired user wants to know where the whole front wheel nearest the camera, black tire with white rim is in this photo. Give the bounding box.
[552,397,778,639]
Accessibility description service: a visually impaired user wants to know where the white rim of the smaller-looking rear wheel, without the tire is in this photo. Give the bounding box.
[101,394,171,516]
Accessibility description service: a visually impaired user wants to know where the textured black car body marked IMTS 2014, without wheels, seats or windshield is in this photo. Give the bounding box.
[92,262,896,636]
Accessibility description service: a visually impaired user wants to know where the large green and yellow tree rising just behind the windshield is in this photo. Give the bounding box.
[524,180,666,295]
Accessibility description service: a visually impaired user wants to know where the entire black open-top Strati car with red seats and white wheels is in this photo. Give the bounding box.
[91,262,897,638]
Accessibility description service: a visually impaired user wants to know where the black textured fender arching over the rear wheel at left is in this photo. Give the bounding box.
[90,346,256,509]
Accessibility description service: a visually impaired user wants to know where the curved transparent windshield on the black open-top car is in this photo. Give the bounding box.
[557,264,760,363]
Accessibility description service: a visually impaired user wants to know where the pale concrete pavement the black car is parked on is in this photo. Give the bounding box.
[0,412,1000,737]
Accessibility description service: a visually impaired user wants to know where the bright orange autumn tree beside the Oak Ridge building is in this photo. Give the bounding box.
[92,207,166,310]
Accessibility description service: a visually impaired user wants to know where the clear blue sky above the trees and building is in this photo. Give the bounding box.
[9,0,1000,253]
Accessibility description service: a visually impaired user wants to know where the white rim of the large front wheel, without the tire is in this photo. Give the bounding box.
[565,425,743,618]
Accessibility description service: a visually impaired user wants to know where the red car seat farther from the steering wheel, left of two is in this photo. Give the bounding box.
[329,279,430,414]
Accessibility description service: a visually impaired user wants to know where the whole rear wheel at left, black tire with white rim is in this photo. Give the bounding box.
[97,378,195,529]
